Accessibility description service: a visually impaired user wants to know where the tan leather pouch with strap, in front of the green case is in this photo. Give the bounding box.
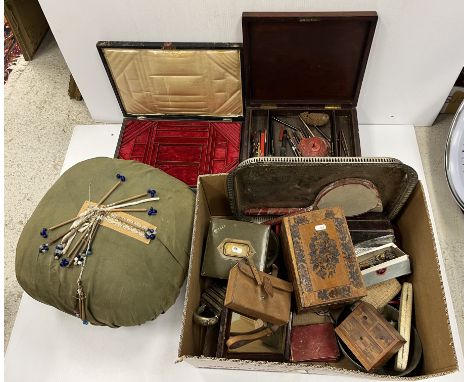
[224,261,293,325]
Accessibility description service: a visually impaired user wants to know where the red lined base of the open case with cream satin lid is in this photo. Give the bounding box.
[119,120,242,187]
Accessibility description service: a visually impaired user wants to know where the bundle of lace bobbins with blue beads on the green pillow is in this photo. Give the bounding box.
[39,174,159,324]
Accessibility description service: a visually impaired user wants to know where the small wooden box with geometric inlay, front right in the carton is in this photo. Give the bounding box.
[335,302,406,371]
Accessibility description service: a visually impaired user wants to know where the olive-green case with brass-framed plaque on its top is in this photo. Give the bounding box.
[201,218,270,279]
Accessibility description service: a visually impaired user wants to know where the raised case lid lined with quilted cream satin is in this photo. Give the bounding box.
[97,41,243,119]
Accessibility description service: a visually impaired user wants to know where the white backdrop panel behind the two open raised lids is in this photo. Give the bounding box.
[39,0,463,125]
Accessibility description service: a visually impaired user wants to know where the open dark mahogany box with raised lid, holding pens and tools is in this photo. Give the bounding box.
[242,12,377,159]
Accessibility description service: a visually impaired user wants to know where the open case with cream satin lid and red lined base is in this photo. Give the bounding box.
[97,41,243,187]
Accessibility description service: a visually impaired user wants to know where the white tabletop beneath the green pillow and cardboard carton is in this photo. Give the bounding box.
[4,125,463,382]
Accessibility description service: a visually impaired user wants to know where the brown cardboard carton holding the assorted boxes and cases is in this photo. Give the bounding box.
[179,174,458,380]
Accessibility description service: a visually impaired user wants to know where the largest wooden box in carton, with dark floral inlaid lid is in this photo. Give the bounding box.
[281,207,366,311]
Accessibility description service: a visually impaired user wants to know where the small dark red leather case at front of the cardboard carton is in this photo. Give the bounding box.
[291,322,340,362]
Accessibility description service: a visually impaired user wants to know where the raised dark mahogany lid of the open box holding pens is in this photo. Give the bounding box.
[242,12,377,108]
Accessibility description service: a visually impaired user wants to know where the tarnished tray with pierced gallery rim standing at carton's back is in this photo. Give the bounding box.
[227,157,418,222]
